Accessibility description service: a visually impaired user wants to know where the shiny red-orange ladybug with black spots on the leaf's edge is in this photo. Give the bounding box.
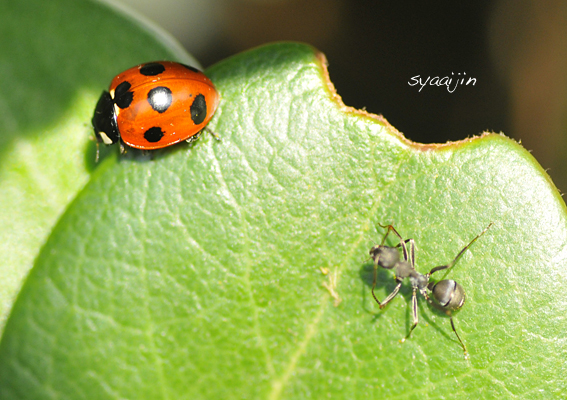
[92,61,219,159]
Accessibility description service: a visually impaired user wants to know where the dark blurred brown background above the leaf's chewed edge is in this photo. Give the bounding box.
[117,0,567,191]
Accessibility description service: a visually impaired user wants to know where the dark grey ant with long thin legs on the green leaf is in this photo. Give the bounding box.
[370,222,493,358]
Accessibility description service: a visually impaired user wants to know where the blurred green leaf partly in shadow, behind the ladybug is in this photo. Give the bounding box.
[0,0,200,333]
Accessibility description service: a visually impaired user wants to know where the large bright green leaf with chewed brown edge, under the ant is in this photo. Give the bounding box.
[0,0,567,399]
